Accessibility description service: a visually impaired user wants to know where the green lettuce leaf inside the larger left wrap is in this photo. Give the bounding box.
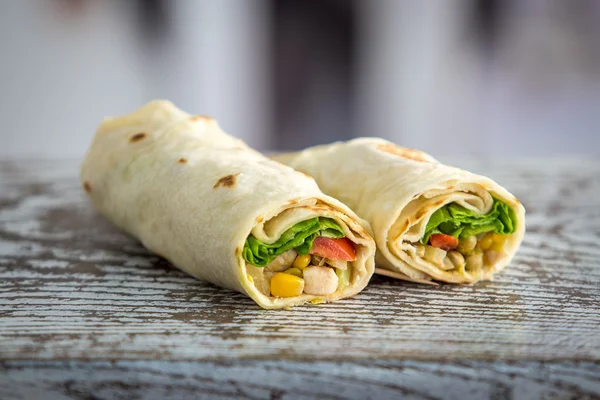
[242,217,344,267]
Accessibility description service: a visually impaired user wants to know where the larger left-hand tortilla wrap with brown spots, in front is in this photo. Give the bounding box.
[80,101,375,309]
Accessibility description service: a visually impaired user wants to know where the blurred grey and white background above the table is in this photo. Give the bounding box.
[0,0,600,158]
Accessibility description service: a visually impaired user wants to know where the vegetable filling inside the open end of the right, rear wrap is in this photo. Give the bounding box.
[415,197,517,273]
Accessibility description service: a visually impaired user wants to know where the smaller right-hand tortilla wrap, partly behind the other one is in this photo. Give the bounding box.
[273,138,525,283]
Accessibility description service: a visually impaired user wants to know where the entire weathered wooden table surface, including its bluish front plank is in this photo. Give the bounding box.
[0,159,600,399]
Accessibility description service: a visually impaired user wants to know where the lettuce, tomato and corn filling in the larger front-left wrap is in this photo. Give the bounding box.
[242,217,356,297]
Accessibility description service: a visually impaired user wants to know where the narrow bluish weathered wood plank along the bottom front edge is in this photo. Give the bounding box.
[0,361,600,400]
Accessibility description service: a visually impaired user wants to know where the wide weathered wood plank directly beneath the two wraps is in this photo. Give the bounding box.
[0,160,600,365]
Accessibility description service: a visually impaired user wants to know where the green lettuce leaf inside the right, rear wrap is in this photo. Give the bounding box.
[421,197,517,244]
